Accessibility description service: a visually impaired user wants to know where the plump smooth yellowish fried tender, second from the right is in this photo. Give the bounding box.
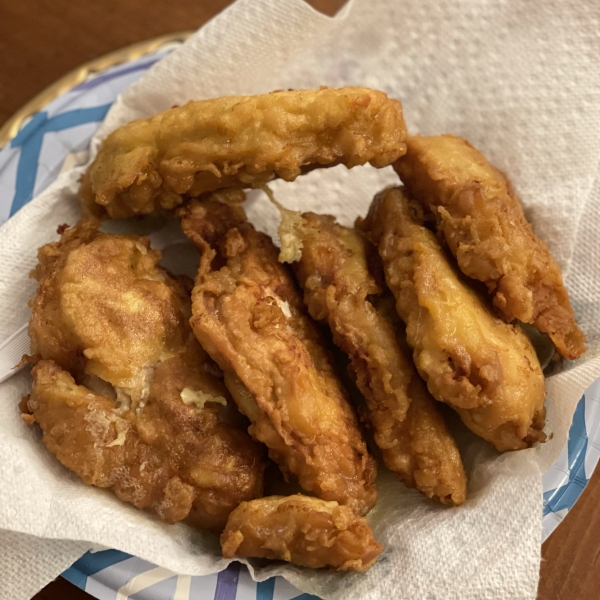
[358,188,545,451]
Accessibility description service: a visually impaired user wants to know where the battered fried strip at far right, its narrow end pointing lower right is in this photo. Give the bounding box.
[394,135,585,359]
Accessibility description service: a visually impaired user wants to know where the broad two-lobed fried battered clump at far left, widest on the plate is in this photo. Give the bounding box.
[21,223,263,531]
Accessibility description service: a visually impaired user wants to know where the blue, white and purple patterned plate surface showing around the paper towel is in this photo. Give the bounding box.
[0,43,600,600]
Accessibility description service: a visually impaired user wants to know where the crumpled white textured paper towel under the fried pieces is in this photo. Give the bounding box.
[0,0,600,600]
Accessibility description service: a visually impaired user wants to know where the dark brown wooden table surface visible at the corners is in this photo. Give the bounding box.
[0,0,600,600]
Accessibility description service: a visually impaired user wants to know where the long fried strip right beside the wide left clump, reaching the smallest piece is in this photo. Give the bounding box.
[179,200,377,514]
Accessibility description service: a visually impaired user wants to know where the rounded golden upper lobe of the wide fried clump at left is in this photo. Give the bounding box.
[29,221,191,408]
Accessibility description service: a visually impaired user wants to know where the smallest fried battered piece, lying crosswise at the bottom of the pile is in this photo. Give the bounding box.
[221,494,383,572]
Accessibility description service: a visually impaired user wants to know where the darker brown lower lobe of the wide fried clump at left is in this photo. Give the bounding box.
[21,356,263,532]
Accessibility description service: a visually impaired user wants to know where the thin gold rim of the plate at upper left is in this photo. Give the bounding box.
[0,31,193,149]
